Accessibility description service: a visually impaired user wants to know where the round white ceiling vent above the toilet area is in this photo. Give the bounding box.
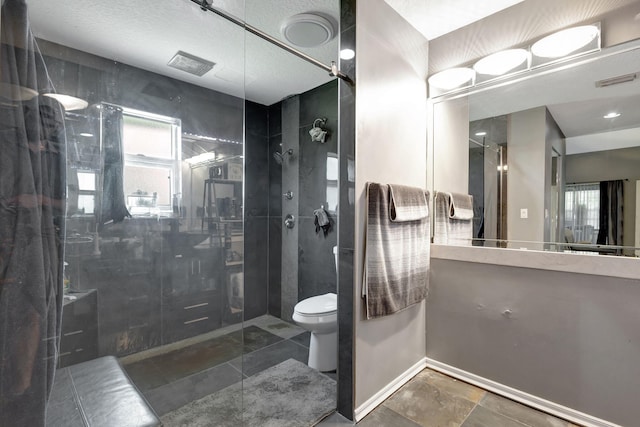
[280,13,336,47]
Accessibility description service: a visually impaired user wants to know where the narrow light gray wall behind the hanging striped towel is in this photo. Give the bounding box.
[353,0,428,416]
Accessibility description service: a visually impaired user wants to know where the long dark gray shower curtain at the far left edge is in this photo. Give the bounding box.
[0,0,65,426]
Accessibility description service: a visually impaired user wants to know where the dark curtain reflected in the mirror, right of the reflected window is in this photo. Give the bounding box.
[598,180,624,245]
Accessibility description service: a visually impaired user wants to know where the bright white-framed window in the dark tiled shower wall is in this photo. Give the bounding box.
[122,108,181,215]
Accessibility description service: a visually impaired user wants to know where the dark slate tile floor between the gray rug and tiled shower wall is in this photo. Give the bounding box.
[123,316,320,416]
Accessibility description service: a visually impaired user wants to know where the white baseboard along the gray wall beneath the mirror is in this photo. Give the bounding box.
[427,358,622,427]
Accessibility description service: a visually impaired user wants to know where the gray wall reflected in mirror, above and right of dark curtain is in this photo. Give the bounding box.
[566,147,640,251]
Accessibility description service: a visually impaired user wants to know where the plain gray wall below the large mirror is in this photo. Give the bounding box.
[427,256,640,426]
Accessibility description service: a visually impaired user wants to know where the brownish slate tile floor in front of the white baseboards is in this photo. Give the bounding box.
[318,369,575,427]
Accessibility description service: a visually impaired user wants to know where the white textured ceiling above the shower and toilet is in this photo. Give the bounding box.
[27,0,339,105]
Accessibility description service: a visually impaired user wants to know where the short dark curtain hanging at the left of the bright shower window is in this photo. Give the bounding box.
[100,104,131,225]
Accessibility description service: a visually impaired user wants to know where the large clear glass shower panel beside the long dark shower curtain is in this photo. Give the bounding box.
[21,0,245,425]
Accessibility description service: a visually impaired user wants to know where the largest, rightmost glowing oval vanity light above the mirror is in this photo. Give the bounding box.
[531,25,600,58]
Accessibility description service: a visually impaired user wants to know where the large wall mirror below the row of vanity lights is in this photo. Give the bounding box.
[431,36,640,256]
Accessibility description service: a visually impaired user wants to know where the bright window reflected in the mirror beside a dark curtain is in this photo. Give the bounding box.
[564,183,600,243]
